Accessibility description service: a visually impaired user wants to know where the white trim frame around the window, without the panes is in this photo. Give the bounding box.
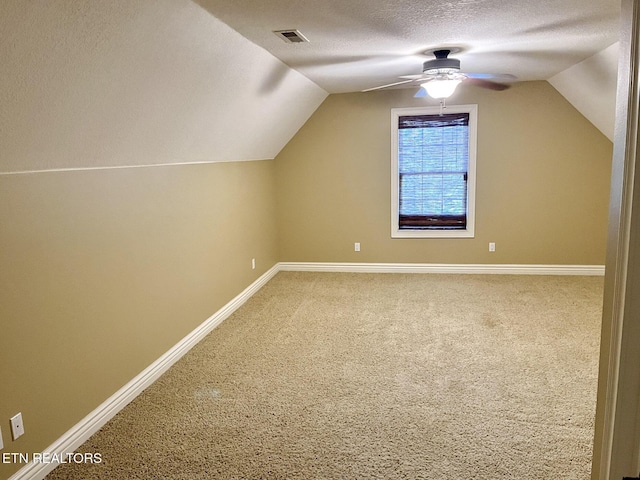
[391,105,478,238]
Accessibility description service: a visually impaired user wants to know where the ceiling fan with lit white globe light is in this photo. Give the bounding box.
[363,48,516,99]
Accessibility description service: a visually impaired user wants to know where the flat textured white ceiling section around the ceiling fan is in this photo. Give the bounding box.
[196,0,620,93]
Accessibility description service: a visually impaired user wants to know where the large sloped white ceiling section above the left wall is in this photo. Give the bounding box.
[0,0,327,172]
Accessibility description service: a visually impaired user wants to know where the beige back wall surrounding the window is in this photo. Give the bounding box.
[276,82,612,265]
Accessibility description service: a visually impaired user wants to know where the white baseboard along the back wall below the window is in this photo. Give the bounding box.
[278,262,604,276]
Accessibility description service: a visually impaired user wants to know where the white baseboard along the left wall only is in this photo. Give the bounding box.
[9,264,279,480]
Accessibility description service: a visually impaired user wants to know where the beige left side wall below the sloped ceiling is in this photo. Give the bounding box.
[0,161,277,478]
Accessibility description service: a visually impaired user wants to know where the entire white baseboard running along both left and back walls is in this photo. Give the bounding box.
[9,262,604,480]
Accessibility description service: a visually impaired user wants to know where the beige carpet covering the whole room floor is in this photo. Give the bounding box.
[47,272,603,480]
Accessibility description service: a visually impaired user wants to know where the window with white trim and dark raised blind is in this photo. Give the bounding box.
[391,105,478,238]
